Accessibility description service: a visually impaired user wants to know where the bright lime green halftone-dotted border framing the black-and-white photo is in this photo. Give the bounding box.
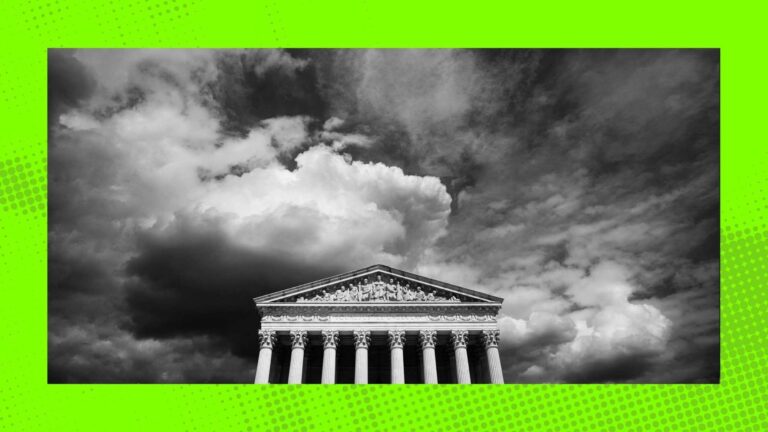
[0,0,768,431]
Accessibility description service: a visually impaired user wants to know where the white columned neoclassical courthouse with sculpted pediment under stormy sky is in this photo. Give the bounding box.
[254,265,504,384]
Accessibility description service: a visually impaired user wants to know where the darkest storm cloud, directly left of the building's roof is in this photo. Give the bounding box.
[126,216,342,356]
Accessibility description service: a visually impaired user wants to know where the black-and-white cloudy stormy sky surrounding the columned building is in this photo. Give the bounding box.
[48,50,719,383]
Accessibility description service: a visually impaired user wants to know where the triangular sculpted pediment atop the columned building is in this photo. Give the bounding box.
[254,265,502,304]
